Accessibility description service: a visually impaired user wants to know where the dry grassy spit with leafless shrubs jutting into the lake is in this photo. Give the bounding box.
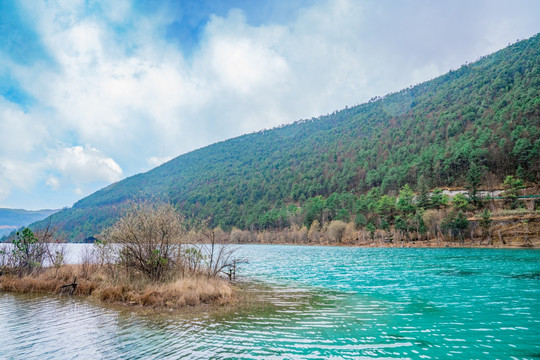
[0,203,236,308]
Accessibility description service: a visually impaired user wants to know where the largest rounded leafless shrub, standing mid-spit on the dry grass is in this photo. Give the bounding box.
[100,202,184,281]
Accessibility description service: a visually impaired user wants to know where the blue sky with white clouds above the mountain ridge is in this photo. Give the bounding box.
[0,0,540,210]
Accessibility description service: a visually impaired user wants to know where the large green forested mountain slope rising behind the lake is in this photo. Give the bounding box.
[34,34,540,240]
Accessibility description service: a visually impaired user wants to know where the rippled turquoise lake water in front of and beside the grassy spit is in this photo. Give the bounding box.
[0,245,540,359]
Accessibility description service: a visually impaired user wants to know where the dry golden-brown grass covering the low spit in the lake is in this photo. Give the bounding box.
[0,265,236,309]
